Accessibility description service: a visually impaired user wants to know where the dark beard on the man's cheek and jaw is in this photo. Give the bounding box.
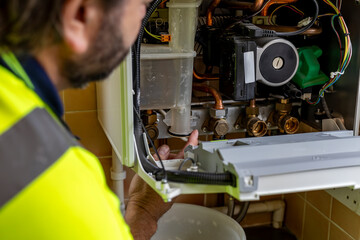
[62,13,129,88]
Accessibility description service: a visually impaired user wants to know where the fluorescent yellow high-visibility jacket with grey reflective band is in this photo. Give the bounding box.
[0,54,132,240]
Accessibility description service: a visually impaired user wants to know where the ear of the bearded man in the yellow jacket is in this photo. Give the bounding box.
[61,0,102,54]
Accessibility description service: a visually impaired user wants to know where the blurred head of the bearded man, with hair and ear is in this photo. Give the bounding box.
[0,0,148,88]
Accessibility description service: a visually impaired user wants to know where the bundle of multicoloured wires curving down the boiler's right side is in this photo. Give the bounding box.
[306,0,352,105]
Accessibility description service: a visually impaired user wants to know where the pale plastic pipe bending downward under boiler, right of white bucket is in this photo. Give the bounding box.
[214,200,285,228]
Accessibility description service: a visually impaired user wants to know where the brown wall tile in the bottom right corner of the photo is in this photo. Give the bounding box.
[331,199,360,239]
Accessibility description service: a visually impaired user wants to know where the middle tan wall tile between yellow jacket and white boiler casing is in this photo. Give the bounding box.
[65,111,111,157]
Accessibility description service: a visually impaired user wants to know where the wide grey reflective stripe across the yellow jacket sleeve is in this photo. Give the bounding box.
[0,108,77,208]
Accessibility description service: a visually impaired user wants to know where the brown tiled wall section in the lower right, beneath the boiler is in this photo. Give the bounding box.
[285,191,360,240]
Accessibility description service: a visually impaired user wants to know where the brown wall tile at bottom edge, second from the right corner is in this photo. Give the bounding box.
[303,204,329,240]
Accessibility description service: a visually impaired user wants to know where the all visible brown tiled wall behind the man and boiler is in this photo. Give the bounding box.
[61,83,360,240]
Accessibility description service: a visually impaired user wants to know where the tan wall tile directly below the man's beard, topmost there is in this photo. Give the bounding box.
[63,83,96,112]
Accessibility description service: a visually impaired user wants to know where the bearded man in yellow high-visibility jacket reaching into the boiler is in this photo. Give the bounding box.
[0,0,197,239]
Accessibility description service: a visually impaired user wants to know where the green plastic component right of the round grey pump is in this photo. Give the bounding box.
[292,46,329,89]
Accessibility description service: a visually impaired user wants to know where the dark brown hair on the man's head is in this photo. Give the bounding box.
[0,0,120,53]
